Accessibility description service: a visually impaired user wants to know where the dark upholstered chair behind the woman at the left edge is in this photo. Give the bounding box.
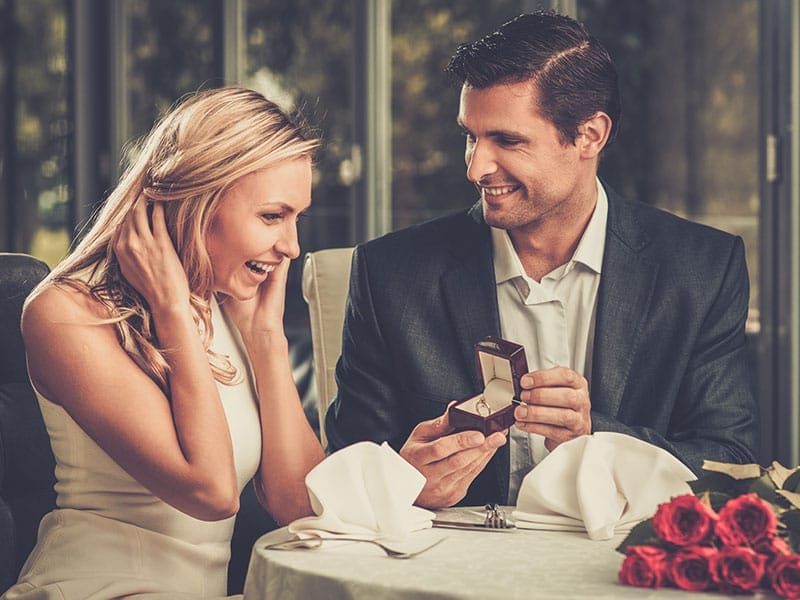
[0,253,55,593]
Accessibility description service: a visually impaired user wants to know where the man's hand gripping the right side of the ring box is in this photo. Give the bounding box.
[514,367,592,450]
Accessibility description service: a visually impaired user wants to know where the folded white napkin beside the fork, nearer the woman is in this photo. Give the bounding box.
[289,442,434,540]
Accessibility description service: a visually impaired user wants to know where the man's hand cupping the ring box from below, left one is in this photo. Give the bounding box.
[400,406,506,509]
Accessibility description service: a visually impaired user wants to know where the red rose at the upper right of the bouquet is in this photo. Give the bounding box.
[715,494,778,546]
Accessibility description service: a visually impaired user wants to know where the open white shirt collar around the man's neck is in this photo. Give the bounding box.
[490,179,608,283]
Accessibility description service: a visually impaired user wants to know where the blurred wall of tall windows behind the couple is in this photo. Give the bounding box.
[0,0,800,465]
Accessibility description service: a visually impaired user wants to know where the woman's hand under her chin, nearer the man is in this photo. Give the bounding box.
[224,257,291,349]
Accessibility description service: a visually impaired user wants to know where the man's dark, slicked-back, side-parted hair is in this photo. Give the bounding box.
[446,11,622,144]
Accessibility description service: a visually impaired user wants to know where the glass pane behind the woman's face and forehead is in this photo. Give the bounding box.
[244,0,357,331]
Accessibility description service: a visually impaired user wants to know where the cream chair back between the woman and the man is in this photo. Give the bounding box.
[302,248,353,447]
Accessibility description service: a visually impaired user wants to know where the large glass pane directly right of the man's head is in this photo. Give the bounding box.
[578,0,759,332]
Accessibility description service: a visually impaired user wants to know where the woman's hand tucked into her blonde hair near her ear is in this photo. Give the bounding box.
[114,196,189,312]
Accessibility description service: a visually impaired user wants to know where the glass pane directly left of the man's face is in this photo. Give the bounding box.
[392,0,520,229]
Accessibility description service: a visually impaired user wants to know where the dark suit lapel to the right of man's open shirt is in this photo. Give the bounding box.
[590,190,658,417]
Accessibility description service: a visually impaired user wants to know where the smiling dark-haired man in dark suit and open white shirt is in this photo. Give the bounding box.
[326,13,757,508]
